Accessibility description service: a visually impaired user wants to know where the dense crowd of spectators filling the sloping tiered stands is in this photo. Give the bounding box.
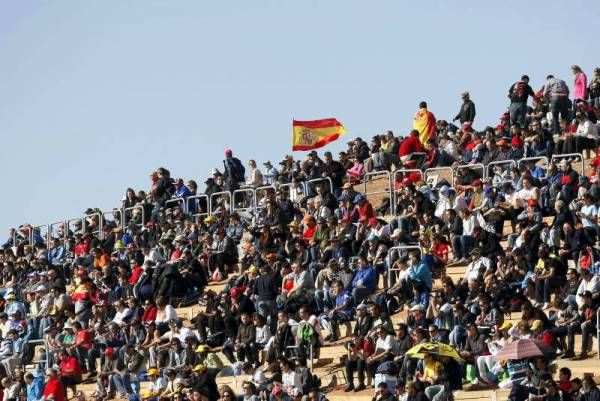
[0,66,600,401]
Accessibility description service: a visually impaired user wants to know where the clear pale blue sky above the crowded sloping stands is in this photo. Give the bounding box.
[0,0,600,233]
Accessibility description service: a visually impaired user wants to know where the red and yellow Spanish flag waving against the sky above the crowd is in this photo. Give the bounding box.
[292,118,346,150]
